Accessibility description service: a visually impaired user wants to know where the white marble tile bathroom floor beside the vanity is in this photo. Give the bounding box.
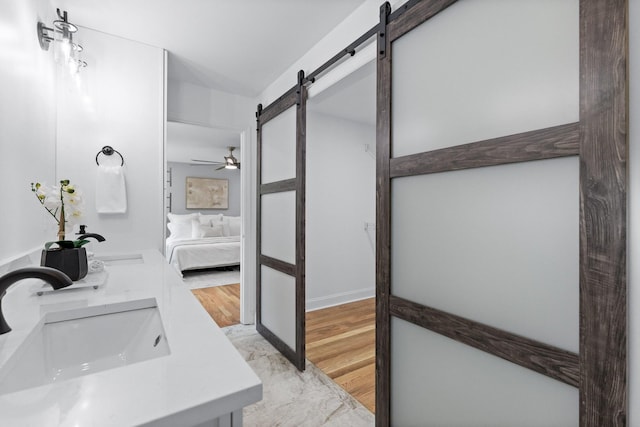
[224,325,375,427]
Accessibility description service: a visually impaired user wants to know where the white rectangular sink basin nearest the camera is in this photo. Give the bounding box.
[0,298,170,394]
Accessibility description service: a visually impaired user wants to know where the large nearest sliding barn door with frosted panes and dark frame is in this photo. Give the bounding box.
[376,0,627,427]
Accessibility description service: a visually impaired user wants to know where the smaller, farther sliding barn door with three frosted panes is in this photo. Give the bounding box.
[256,73,306,371]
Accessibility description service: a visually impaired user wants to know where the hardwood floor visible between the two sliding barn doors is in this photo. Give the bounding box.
[306,298,376,413]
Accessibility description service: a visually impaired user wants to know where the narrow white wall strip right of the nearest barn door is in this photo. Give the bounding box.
[627,0,640,426]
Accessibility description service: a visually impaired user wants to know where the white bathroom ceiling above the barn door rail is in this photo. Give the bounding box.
[53,0,364,96]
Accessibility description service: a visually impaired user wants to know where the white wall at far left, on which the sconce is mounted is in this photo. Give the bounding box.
[0,0,56,264]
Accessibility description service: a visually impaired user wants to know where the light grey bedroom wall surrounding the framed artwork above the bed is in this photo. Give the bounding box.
[167,162,240,216]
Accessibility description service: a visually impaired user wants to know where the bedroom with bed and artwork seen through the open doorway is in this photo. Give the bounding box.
[165,121,242,327]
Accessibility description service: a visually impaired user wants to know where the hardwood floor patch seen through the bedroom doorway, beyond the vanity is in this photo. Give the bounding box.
[191,283,240,328]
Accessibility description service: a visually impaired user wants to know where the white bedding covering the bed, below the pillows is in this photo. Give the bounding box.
[166,236,240,272]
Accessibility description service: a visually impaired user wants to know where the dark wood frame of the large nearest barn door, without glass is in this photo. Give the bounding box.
[376,0,628,427]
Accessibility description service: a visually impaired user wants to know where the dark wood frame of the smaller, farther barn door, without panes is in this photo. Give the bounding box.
[256,71,307,371]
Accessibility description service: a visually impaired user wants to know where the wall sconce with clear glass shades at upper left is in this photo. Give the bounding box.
[37,9,87,74]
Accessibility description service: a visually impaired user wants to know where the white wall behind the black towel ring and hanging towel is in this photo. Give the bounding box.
[57,28,164,252]
